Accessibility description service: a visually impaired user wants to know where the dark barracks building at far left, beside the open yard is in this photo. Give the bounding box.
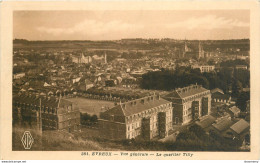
[13,94,80,132]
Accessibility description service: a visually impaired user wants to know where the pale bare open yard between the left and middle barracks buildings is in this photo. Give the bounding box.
[67,97,114,116]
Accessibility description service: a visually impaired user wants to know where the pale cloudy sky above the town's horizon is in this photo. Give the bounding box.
[13,10,250,40]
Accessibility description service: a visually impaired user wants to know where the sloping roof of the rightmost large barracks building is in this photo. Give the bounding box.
[165,85,208,98]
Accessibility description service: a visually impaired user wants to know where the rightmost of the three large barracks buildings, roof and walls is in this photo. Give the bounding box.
[163,84,211,124]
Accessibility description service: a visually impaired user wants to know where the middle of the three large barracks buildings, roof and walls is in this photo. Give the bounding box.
[99,95,172,140]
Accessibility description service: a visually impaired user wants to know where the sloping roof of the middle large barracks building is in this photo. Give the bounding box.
[104,96,170,116]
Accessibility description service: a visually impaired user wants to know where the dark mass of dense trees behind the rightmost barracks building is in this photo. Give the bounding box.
[140,63,250,97]
